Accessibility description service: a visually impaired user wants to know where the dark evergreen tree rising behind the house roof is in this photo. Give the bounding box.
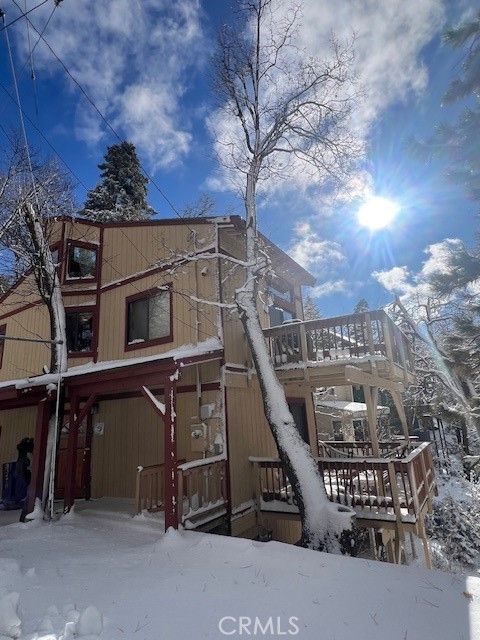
[82,141,153,222]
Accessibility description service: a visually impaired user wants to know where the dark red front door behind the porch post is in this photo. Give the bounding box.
[55,414,92,500]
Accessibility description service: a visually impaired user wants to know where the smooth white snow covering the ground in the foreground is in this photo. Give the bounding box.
[0,507,480,640]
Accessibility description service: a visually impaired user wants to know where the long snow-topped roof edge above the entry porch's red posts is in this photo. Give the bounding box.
[0,338,223,389]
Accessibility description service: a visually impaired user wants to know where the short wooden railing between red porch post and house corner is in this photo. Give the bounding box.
[178,457,227,524]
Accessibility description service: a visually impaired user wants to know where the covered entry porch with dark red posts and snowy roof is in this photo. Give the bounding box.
[0,339,229,528]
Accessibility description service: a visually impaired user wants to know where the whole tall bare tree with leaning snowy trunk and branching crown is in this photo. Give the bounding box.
[216,0,358,550]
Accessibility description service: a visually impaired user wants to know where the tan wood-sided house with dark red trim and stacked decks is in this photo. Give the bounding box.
[0,216,434,562]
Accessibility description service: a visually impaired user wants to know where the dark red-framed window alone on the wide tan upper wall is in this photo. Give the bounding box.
[127,289,172,346]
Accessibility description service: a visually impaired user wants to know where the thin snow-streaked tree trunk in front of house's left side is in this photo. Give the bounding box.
[23,201,67,509]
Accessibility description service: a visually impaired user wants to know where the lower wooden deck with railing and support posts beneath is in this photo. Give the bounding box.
[250,442,436,566]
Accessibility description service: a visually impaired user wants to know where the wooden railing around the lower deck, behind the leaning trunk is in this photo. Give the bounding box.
[251,442,435,521]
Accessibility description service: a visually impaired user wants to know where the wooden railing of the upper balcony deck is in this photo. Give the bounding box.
[263,310,413,371]
